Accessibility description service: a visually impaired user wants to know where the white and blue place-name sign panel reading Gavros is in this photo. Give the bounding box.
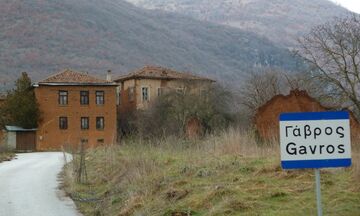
[280,112,351,169]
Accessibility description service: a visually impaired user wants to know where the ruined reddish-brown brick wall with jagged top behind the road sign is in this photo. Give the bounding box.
[254,90,360,141]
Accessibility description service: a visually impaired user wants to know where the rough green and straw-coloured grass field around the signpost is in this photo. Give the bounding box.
[64,129,360,216]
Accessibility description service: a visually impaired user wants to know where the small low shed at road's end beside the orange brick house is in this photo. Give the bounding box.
[4,126,37,151]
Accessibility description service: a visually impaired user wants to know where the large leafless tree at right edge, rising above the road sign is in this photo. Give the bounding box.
[298,14,360,113]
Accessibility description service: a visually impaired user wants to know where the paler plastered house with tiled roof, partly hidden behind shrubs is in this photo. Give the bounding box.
[114,66,215,113]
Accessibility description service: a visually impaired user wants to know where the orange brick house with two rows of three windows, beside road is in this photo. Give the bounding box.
[34,69,117,151]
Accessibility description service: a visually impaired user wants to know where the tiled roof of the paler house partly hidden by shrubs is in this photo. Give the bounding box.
[115,66,214,82]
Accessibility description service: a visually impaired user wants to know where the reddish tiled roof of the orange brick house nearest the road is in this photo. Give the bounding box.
[38,69,113,85]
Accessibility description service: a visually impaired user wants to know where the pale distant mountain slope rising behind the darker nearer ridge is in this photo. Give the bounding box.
[127,0,348,47]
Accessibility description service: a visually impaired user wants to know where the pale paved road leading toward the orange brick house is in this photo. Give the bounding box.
[0,152,80,216]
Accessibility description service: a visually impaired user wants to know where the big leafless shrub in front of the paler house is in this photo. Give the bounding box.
[136,83,234,137]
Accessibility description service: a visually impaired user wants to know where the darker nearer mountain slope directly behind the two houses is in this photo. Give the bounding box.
[0,0,299,88]
